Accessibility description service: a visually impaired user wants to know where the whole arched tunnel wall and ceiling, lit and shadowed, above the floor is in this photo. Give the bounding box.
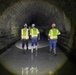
[0,0,76,75]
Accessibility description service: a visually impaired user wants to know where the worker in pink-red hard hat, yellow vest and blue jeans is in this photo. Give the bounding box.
[48,23,60,55]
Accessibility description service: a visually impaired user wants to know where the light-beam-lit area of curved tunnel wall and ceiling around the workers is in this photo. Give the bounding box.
[0,0,75,58]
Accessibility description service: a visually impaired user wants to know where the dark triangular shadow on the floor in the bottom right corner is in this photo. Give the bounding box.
[54,60,76,75]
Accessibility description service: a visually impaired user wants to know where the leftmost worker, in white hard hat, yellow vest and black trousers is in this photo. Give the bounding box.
[21,24,29,53]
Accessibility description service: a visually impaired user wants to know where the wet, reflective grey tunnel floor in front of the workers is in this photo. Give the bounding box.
[0,39,76,75]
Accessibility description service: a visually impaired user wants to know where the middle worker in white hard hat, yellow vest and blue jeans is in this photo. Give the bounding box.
[30,24,40,53]
